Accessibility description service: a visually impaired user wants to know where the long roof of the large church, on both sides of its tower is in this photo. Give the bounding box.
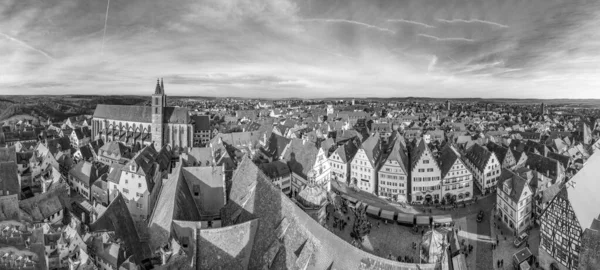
[94,104,190,124]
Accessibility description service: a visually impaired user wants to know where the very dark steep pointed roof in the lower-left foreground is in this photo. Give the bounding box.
[90,193,152,264]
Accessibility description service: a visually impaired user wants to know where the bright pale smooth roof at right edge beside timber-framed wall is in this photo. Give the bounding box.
[567,152,600,230]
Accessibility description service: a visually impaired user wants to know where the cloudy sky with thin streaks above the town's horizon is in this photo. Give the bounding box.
[0,0,600,98]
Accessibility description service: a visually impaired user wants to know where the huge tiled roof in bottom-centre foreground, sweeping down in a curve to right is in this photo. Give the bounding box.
[219,158,435,270]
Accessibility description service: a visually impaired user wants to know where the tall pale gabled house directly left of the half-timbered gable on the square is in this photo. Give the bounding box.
[408,139,442,204]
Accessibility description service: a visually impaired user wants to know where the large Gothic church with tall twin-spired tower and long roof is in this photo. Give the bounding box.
[91,80,194,149]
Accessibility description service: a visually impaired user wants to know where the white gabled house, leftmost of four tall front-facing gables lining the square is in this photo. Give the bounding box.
[350,133,382,193]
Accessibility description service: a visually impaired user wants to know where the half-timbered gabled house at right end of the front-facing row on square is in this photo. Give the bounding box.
[438,145,473,203]
